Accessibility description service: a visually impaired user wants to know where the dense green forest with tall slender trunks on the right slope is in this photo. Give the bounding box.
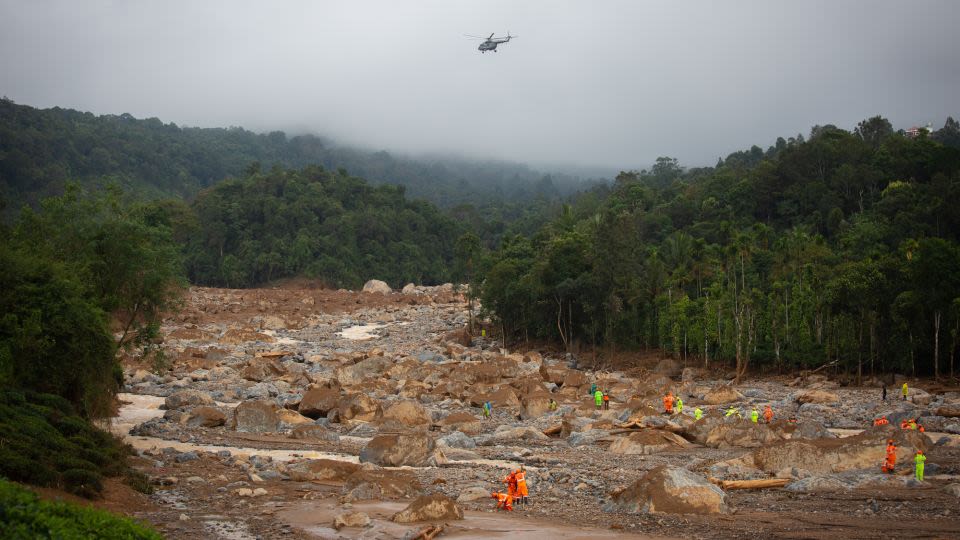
[480,117,960,376]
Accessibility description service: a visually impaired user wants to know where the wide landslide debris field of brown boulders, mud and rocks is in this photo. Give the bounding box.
[104,286,960,539]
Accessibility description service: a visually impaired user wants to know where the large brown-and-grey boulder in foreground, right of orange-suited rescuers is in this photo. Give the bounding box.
[604,466,729,514]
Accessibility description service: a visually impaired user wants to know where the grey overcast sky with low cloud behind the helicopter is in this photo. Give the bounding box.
[0,0,960,169]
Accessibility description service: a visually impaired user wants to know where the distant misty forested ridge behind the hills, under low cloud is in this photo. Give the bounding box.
[0,99,600,211]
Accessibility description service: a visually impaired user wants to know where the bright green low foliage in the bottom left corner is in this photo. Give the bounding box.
[0,479,163,540]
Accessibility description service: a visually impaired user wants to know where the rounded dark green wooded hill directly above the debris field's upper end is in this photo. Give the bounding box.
[151,166,462,289]
